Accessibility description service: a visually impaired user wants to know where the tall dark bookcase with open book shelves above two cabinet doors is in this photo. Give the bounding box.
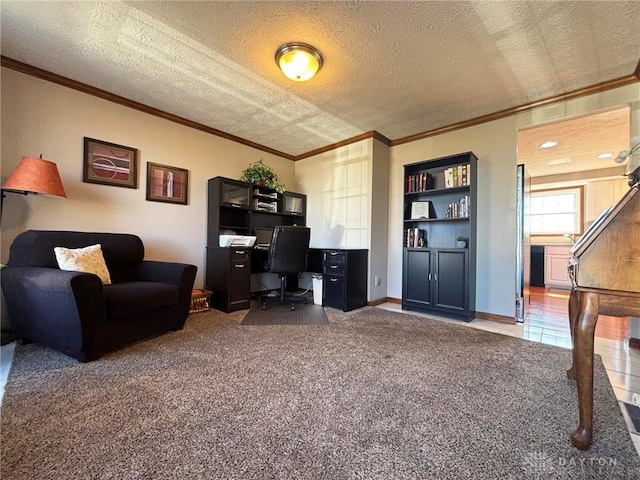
[402,152,477,321]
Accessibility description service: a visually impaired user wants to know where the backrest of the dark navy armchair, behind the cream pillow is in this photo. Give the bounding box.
[7,230,144,283]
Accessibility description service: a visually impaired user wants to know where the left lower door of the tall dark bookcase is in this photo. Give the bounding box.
[402,249,433,307]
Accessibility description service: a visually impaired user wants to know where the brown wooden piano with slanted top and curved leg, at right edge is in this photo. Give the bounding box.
[567,182,640,450]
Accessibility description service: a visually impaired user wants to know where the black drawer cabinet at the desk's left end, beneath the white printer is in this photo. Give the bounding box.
[205,247,251,313]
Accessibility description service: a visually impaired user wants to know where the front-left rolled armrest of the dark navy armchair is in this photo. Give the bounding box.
[1,267,106,358]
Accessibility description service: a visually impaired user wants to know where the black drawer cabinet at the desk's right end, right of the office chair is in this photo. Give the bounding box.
[322,250,368,312]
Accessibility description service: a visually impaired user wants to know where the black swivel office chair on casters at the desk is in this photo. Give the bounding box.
[260,225,311,310]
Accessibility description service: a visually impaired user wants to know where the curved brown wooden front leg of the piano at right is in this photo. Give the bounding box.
[571,292,599,450]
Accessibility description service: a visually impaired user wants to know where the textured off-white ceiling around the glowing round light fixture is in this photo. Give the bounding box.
[0,0,640,156]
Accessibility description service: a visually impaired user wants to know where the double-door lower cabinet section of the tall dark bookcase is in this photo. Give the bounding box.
[402,248,469,316]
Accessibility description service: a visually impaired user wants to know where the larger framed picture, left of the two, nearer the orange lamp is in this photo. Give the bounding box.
[82,137,138,188]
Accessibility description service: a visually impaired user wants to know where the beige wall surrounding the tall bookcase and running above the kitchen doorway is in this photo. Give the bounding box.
[388,83,640,317]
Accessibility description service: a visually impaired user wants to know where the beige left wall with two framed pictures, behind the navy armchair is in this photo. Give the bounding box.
[1,68,296,287]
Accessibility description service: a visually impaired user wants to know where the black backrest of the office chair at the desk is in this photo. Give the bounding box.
[269,225,311,273]
